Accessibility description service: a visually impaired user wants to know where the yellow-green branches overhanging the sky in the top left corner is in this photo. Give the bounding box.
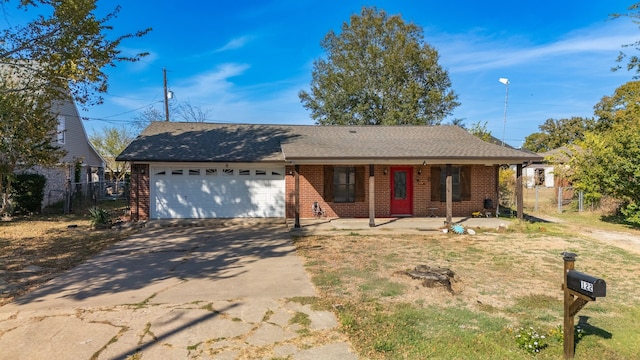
[0,0,151,105]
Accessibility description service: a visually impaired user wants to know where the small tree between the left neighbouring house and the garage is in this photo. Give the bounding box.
[89,127,134,190]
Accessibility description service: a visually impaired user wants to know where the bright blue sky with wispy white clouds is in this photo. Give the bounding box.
[11,0,640,146]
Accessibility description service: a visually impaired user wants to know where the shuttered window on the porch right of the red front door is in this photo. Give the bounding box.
[431,166,471,202]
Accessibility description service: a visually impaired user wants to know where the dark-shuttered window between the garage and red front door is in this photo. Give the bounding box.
[324,166,364,203]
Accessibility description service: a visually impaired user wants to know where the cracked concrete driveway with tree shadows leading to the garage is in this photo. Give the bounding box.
[0,221,357,360]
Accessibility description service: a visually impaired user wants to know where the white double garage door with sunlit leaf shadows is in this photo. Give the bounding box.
[151,169,285,219]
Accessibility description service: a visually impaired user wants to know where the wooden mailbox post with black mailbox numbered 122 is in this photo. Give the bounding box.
[561,252,607,359]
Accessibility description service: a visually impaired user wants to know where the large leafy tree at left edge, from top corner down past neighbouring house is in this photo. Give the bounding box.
[0,0,150,211]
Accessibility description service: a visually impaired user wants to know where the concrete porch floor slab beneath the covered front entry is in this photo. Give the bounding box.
[287,217,512,236]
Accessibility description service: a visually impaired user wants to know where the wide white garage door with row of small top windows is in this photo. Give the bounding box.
[150,167,285,219]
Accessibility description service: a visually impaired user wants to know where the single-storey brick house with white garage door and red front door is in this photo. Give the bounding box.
[117,122,540,220]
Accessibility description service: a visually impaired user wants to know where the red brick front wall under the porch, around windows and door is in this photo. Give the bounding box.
[286,165,497,218]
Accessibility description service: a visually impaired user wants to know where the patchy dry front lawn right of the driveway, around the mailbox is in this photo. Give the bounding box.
[296,224,640,359]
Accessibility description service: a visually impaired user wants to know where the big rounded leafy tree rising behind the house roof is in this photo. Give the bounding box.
[299,7,459,125]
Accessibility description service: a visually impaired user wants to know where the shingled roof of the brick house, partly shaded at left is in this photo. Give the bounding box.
[117,122,542,164]
